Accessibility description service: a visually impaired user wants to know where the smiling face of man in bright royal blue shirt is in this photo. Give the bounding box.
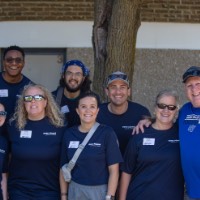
[185,76,200,108]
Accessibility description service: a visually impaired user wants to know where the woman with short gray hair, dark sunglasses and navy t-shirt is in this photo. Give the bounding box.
[119,90,184,200]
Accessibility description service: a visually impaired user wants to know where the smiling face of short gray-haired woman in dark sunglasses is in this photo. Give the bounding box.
[155,95,178,127]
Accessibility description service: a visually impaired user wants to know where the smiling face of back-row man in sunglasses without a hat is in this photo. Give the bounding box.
[3,50,24,79]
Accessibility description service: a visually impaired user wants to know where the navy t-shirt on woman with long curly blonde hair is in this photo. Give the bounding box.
[8,118,65,199]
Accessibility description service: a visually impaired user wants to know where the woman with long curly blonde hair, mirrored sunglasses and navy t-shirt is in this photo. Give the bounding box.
[8,84,65,200]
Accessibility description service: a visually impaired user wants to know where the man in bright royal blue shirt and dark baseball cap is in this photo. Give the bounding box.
[179,66,200,200]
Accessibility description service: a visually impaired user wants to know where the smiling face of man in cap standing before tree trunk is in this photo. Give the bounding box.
[106,80,130,106]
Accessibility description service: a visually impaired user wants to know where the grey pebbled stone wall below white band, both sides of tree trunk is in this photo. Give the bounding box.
[67,48,200,113]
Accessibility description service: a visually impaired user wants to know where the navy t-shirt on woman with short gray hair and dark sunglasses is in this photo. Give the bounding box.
[121,126,184,200]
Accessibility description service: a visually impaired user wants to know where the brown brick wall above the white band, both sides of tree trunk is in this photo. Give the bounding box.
[0,0,200,23]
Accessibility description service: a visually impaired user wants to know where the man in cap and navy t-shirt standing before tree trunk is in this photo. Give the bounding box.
[97,71,150,155]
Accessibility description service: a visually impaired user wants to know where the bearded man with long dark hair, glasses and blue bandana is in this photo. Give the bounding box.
[53,60,91,127]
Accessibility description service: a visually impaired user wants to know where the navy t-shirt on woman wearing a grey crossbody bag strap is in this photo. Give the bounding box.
[61,125,122,185]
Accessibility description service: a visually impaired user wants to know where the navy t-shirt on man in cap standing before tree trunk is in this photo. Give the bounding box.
[97,101,150,155]
